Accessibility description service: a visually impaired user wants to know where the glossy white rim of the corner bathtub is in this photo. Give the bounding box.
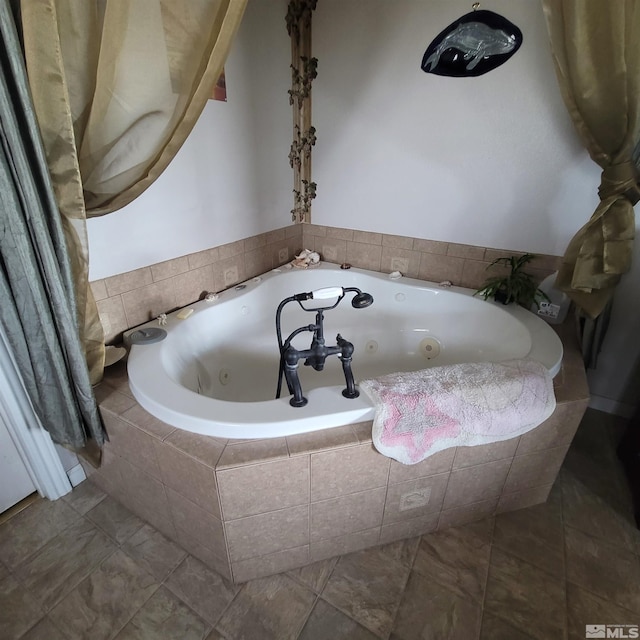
[124,262,563,439]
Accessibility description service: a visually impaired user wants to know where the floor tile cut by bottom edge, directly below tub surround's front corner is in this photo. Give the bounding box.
[216,574,316,640]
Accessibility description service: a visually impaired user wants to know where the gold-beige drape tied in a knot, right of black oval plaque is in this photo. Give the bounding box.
[543,0,640,318]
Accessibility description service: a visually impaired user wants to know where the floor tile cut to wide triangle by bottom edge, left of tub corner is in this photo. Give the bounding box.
[115,587,211,640]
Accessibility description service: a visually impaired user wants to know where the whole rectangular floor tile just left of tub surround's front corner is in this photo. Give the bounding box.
[165,556,240,625]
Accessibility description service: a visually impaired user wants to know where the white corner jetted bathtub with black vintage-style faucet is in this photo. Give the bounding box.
[125,263,562,439]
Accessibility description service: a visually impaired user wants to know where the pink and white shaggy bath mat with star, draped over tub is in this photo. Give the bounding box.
[358,359,556,464]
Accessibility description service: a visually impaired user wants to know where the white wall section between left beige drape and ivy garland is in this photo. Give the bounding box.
[87,0,293,280]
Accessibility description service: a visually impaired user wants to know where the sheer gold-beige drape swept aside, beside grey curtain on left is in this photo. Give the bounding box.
[21,0,247,383]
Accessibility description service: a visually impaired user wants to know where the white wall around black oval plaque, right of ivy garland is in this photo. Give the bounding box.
[312,0,640,411]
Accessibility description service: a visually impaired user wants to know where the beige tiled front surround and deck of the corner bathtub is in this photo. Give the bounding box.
[86,326,588,582]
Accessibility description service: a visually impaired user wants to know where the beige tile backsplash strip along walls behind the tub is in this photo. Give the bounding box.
[91,224,560,344]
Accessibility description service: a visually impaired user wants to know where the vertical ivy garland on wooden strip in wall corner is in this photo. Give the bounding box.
[286,0,318,222]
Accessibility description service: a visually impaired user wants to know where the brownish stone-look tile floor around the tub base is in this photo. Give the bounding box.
[0,410,640,640]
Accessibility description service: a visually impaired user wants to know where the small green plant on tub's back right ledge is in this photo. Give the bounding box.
[474,253,549,309]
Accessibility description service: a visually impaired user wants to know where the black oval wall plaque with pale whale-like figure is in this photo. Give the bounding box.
[421,10,522,78]
